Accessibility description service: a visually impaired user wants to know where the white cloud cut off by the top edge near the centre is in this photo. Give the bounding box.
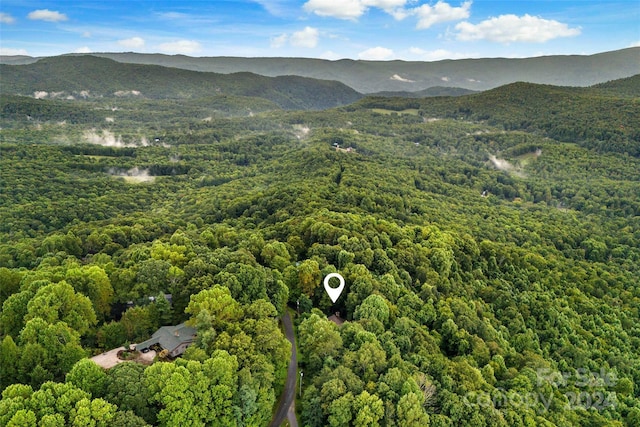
[303,0,407,20]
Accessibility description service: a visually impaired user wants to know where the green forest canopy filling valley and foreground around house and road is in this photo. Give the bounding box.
[0,73,640,427]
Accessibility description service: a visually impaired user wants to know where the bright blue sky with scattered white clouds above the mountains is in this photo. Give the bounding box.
[0,0,640,61]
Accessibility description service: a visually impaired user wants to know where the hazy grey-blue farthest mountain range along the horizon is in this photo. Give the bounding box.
[5,48,640,94]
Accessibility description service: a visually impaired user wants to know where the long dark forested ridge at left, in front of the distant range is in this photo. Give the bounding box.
[0,55,361,110]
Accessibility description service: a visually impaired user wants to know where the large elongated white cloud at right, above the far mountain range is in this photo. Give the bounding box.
[455,14,580,43]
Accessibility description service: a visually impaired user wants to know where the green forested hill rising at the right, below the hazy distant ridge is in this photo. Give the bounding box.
[360,76,640,157]
